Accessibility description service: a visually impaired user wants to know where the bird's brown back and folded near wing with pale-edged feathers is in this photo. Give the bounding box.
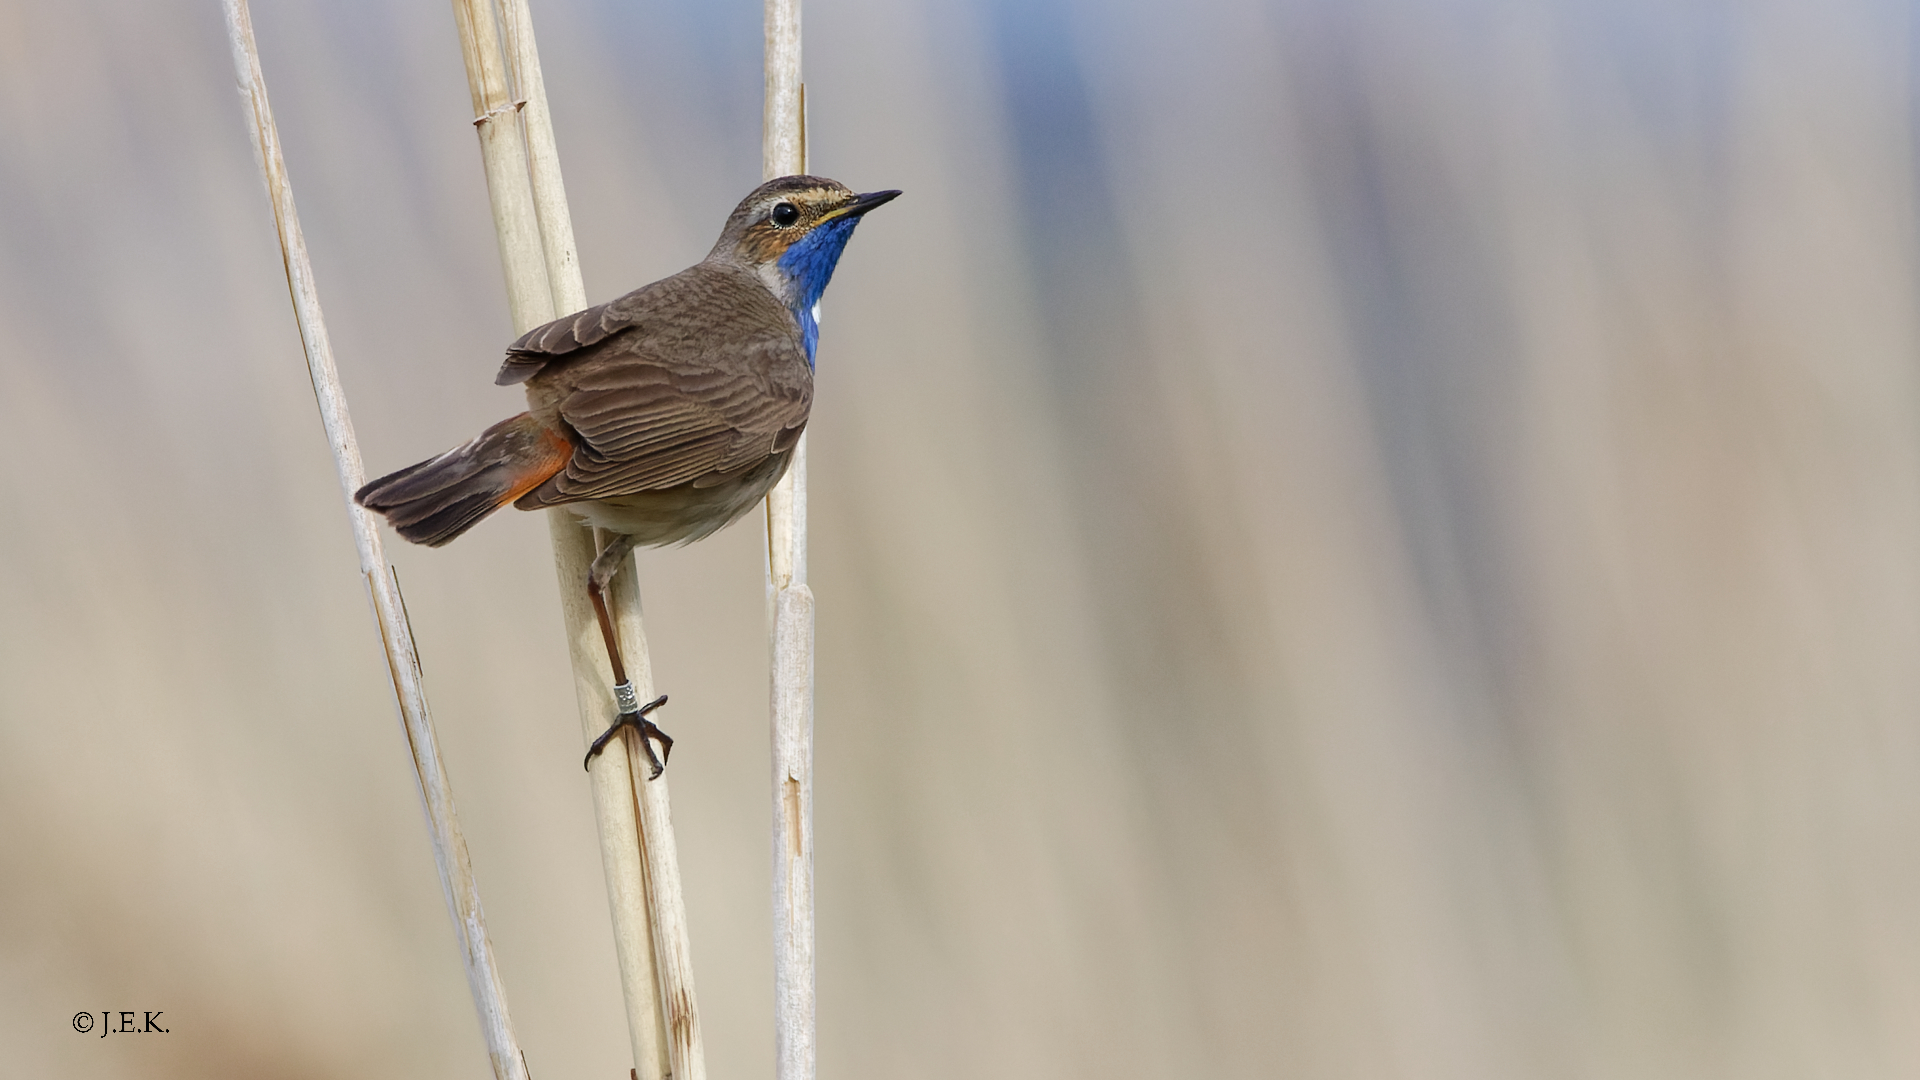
[509,267,812,507]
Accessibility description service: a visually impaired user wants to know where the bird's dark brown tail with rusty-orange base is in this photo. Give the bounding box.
[353,413,574,548]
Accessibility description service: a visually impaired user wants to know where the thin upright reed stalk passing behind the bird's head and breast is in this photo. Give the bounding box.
[760,0,814,1080]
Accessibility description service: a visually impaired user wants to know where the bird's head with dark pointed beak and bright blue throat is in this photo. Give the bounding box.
[707,177,900,349]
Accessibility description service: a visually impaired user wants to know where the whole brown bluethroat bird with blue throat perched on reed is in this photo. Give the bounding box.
[353,177,900,776]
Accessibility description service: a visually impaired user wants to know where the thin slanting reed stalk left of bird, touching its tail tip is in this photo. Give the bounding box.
[225,0,526,1080]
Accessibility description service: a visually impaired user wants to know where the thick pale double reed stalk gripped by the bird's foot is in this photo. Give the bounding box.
[453,0,707,1080]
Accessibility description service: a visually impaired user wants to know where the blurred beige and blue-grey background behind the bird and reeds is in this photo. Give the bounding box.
[0,0,1920,1080]
